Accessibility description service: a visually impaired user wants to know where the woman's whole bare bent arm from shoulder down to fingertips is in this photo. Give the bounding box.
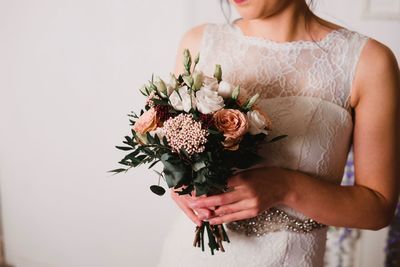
[191,40,400,230]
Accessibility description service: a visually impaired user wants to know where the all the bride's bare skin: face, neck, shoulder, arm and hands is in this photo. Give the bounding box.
[171,0,400,230]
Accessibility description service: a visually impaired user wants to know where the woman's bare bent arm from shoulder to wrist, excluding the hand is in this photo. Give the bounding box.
[282,40,400,229]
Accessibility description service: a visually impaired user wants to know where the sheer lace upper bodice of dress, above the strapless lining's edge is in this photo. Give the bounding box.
[199,24,367,110]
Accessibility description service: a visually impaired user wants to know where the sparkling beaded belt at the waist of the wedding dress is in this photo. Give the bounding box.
[226,208,326,236]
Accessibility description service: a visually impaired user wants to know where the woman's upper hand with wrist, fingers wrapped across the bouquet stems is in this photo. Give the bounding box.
[189,168,290,224]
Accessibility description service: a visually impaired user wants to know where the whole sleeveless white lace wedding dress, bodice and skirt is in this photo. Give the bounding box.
[155,24,368,267]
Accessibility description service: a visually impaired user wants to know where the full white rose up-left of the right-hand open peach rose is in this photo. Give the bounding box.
[196,86,224,114]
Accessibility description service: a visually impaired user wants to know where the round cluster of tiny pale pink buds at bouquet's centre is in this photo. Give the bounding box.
[163,113,208,155]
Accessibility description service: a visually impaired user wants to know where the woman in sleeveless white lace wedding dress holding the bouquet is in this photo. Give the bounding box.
[159,0,400,266]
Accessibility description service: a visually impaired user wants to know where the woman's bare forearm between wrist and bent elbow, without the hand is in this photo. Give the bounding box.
[283,170,394,230]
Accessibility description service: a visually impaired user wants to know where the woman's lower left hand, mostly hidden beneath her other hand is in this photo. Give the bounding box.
[171,189,212,226]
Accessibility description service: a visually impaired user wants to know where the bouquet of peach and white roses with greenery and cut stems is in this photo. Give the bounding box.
[110,50,284,254]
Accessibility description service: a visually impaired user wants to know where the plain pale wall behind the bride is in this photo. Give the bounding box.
[0,0,400,267]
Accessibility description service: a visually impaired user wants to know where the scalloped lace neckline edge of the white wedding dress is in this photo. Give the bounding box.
[229,22,346,48]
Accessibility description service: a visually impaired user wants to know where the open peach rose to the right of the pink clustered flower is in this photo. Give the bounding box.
[213,109,249,150]
